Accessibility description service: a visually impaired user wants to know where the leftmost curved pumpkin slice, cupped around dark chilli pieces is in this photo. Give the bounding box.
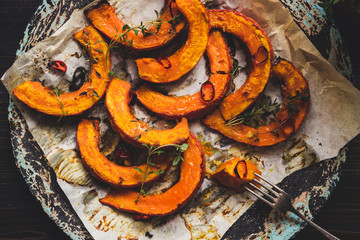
[13,26,111,116]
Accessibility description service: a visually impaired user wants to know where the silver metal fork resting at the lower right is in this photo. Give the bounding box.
[245,173,339,240]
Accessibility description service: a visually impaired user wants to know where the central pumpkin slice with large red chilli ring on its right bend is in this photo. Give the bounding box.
[136,30,231,119]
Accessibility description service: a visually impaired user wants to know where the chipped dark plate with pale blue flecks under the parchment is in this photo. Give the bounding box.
[9,0,354,239]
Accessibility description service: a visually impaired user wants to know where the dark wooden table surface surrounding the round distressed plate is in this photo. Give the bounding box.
[0,0,360,240]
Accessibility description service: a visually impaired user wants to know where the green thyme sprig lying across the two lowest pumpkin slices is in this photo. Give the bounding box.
[135,143,189,203]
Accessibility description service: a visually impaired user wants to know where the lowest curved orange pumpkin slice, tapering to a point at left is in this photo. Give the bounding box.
[100,134,205,216]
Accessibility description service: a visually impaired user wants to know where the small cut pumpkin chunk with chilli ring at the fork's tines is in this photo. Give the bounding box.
[210,158,261,192]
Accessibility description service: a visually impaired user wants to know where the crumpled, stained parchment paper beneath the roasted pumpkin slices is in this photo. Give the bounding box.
[2,0,360,239]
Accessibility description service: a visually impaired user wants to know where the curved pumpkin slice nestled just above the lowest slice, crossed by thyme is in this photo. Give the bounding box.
[76,119,172,187]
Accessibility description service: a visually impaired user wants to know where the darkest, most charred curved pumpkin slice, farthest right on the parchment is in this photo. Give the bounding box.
[203,59,310,146]
